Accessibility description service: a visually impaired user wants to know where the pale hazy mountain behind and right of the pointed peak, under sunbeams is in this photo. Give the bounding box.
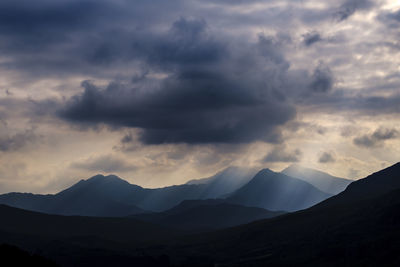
[282,164,353,195]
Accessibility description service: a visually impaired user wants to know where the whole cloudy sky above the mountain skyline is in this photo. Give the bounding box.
[0,0,400,193]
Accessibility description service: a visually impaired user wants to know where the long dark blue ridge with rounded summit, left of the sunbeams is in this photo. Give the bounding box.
[0,175,250,217]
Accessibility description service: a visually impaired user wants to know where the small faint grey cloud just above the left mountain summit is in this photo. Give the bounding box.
[71,155,136,173]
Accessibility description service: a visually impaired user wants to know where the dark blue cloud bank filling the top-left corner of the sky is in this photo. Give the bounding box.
[0,0,184,78]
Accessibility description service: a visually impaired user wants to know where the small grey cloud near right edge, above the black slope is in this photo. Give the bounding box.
[353,127,399,148]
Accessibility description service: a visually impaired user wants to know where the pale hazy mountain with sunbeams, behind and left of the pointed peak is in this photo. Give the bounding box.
[186,167,257,198]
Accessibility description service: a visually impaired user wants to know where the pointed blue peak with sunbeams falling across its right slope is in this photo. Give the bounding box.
[227,169,331,211]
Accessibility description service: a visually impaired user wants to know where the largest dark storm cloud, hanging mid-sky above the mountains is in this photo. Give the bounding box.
[60,18,304,144]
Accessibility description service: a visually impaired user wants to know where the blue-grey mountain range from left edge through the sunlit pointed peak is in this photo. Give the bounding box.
[0,168,330,217]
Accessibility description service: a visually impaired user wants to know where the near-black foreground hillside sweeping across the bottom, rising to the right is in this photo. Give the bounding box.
[0,163,400,266]
